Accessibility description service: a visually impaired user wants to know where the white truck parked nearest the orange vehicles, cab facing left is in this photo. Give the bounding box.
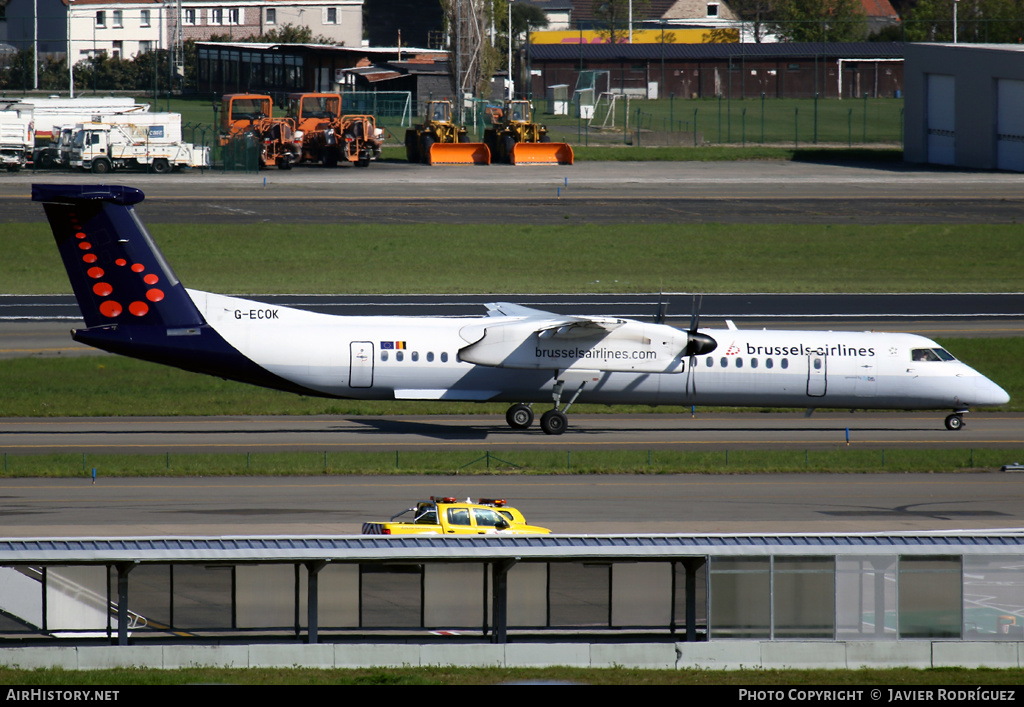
[70,113,210,174]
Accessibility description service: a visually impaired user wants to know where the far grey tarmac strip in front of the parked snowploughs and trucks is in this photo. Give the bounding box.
[6,161,1024,224]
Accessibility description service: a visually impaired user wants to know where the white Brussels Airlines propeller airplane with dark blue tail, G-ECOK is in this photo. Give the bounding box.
[32,184,1010,434]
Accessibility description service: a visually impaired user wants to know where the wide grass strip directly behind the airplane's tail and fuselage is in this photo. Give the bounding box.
[6,223,1024,294]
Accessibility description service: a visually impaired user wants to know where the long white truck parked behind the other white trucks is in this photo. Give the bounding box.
[0,97,150,168]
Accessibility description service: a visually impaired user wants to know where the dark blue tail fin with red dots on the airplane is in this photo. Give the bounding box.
[32,184,204,329]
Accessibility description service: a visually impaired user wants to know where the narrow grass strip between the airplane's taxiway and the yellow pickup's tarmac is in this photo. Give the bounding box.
[0,442,1020,479]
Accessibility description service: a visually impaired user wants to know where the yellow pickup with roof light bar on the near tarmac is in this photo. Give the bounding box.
[362,496,551,535]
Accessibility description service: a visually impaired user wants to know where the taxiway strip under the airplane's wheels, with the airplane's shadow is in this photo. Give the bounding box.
[0,409,1024,450]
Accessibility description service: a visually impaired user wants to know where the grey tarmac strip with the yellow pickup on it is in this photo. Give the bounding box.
[0,473,1024,537]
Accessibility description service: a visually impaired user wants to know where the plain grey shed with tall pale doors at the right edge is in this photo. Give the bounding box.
[903,44,1024,172]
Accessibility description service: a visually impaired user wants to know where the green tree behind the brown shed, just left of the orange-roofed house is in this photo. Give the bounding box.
[771,0,867,42]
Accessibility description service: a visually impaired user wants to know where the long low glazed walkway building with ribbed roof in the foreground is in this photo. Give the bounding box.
[0,532,1024,667]
